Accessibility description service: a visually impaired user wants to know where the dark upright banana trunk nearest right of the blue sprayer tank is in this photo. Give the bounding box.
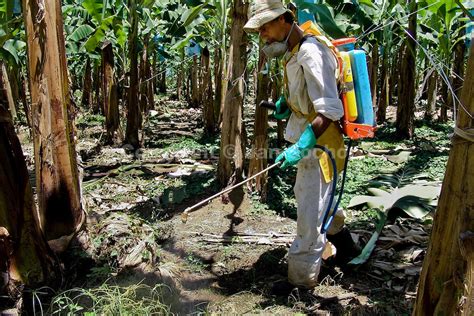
[396,0,417,139]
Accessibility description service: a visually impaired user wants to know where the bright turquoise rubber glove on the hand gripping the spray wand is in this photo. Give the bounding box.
[275,124,316,169]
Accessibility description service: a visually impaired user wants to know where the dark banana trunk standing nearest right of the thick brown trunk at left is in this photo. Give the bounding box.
[102,41,120,143]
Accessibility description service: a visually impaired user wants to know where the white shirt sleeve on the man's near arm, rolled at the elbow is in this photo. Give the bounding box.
[297,38,344,121]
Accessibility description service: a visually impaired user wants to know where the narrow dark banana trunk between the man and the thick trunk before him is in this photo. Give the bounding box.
[249,52,270,202]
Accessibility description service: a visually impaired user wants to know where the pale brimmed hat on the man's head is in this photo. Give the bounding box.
[244,0,291,32]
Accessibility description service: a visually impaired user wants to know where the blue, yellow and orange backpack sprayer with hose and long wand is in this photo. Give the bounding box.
[181,26,376,230]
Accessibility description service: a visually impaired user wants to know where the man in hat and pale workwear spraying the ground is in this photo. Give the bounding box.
[244,0,360,288]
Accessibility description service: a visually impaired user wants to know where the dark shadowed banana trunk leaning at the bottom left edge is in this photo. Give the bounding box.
[0,105,58,302]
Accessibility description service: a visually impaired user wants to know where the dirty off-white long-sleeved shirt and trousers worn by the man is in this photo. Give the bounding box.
[285,37,344,288]
